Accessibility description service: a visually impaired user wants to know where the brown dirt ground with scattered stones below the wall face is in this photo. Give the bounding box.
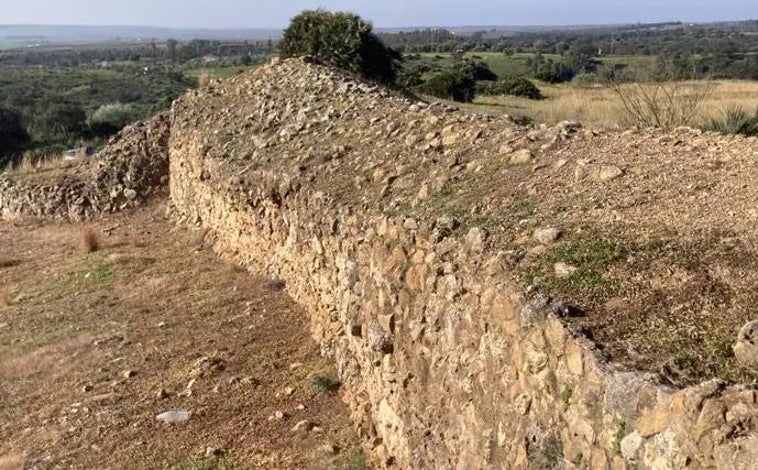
[0,205,366,469]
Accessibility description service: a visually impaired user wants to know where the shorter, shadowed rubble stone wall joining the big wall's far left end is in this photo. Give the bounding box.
[0,113,171,220]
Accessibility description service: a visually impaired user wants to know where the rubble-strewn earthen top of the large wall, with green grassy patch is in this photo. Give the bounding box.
[177,59,758,383]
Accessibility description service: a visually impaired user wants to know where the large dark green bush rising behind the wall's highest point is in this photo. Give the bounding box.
[279,10,402,83]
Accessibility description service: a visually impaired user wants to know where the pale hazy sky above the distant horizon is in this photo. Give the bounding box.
[5,0,758,28]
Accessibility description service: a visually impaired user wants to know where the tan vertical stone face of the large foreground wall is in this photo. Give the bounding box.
[170,128,758,469]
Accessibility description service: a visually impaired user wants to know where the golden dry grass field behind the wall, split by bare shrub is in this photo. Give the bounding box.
[475,80,758,128]
